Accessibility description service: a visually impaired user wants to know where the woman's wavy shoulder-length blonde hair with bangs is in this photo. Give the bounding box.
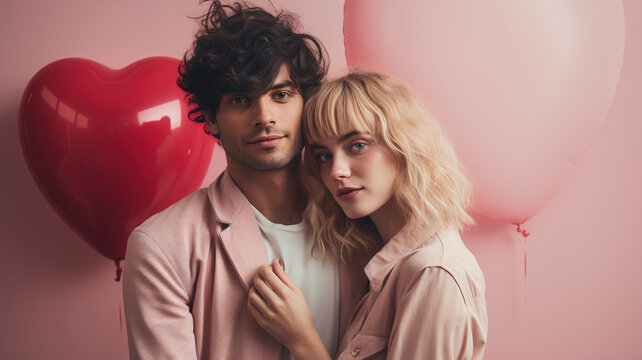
[302,72,473,260]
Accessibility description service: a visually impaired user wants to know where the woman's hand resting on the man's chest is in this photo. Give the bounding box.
[248,260,330,359]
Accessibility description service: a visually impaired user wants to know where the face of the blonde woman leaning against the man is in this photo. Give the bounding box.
[309,131,397,219]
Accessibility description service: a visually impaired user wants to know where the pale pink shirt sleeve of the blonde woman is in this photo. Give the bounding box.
[388,267,473,360]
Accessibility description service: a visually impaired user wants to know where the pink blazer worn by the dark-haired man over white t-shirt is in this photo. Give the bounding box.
[123,172,368,360]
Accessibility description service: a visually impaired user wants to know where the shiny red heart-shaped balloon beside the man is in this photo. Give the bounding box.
[20,57,214,260]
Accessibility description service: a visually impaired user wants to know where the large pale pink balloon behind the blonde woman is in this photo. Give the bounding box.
[344,0,624,223]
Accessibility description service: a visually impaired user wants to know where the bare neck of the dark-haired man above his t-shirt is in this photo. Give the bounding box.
[228,156,307,225]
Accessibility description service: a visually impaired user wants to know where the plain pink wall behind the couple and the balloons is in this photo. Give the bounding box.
[0,0,642,360]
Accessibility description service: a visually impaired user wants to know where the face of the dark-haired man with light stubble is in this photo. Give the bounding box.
[208,64,303,171]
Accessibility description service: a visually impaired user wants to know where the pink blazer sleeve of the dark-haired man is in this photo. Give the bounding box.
[123,230,196,360]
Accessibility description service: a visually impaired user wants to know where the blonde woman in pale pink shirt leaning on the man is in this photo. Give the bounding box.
[248,73,487,360]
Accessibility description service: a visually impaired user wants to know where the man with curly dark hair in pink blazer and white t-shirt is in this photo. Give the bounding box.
[123,1,366,360]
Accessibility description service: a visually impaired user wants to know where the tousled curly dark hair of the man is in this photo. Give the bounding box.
[177,1,328,134]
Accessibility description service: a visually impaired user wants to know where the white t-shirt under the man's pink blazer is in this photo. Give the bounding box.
[252,206,340,359]
